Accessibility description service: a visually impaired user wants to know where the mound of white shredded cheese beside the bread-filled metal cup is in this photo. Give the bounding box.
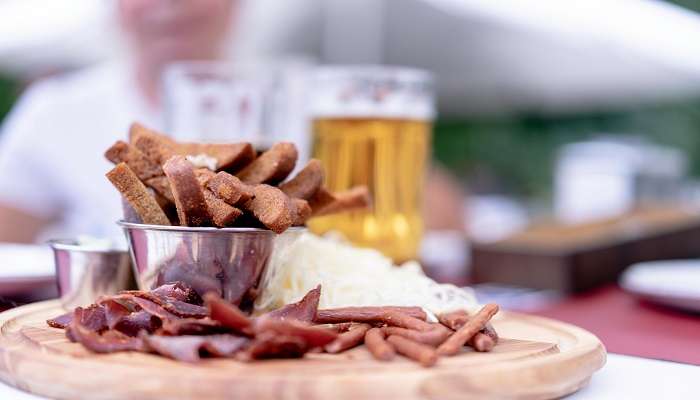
[255,231,477,318]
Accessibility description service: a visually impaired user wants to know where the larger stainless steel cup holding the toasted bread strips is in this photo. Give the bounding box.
[119,221,276,307]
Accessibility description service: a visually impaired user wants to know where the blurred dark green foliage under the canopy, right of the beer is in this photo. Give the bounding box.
[433,99,700,196]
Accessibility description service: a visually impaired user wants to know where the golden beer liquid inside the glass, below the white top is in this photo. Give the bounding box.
[309,117,431,261]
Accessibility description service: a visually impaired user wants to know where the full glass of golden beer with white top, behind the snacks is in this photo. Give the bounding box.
[309,66,435,262]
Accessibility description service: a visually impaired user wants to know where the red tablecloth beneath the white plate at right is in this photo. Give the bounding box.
[534,286,700,365]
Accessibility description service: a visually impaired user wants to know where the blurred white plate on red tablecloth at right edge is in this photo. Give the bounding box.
[620,260,700,312]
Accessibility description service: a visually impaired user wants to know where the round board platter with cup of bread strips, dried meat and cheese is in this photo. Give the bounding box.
[0,124,605,399]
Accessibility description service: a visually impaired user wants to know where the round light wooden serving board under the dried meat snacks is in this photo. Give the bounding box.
[0,301,606,400]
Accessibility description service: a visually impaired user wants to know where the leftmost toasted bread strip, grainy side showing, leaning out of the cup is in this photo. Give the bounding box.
[107,162,170,225]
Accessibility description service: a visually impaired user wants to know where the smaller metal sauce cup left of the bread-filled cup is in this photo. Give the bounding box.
[49,240,136,310]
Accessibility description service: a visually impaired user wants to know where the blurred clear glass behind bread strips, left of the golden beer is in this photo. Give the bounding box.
[162,60,308,156]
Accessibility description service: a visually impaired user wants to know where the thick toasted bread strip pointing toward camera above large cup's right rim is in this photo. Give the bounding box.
[244,185,294,233]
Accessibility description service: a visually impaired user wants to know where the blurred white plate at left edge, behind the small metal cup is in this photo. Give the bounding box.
[0,243,56,296]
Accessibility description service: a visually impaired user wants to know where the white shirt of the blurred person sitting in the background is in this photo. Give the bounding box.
[0,65,162,241]
